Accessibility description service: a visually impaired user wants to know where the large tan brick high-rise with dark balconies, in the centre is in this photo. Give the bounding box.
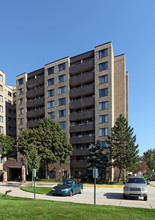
[16,42,128,179]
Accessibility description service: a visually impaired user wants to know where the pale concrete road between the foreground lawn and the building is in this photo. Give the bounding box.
[0,186,155,209]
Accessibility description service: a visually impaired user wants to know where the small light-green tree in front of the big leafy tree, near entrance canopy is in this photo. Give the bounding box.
[25,144,40,171]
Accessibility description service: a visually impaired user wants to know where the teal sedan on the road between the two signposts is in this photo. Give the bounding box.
[51,179,83,196]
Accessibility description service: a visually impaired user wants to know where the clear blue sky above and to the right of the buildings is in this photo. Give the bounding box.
[0,0,155,155]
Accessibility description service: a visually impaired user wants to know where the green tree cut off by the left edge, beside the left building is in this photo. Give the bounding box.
[0,134,14,157]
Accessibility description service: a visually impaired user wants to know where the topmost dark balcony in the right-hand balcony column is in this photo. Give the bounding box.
[69,59,94,75]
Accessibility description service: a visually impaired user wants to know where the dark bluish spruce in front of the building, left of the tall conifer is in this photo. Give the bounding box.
[87,141,108,179]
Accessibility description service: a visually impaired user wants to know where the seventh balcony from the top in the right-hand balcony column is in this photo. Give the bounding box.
[70,135,95,144]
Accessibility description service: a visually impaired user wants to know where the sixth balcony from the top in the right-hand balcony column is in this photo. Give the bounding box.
[70,123,95,133]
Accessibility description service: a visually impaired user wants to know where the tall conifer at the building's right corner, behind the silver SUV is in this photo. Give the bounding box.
[107,114,139,182]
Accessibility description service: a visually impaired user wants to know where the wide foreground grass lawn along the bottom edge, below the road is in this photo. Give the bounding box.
[0,195,155,220]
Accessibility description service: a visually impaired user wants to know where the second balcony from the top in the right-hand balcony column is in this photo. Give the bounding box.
[70,71,94,86]
